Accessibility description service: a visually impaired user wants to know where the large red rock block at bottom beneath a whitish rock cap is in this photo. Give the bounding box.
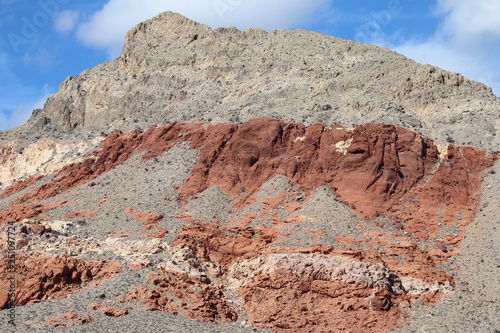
[240,271,409,333]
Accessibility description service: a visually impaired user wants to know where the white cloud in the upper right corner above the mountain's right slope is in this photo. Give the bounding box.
[386,0,500,95]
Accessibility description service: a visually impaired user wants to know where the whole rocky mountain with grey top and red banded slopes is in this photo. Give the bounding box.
[0,12,500,332]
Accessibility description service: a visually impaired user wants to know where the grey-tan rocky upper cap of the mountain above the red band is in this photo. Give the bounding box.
[25,12,500,150]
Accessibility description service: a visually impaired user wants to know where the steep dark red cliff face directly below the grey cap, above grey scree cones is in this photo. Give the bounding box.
[181,118,437,218]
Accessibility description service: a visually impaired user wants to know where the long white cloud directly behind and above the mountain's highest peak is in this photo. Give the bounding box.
[77,0,327,57]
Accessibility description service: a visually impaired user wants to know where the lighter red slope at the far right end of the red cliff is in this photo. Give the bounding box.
[387,145,500,239]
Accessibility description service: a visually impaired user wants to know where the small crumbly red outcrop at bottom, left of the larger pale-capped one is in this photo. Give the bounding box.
[125,271,238,323]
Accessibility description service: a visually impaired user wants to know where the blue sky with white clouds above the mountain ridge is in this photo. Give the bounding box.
[0,0,500,130]
